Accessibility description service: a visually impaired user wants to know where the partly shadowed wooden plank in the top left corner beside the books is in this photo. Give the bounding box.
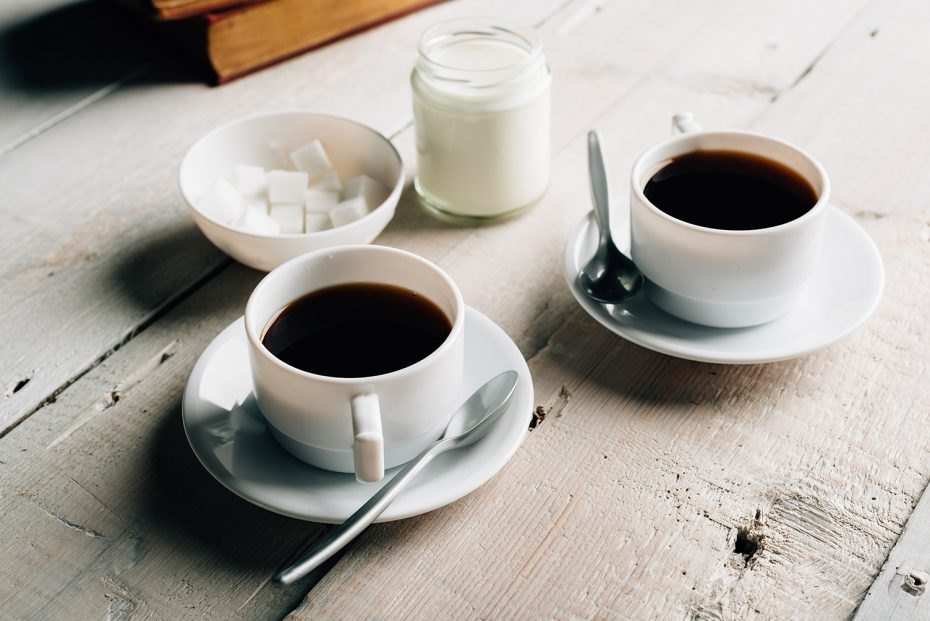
[0,0,163,156]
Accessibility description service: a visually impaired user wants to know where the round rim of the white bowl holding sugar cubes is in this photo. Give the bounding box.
[177,108,406,240]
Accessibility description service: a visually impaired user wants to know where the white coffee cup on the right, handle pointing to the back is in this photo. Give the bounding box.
[630,115,830,328]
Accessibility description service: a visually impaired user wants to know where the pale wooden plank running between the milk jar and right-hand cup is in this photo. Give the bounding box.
[379,2,861,357]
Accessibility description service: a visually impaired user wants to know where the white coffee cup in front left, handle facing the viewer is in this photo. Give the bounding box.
[245,245,465,482]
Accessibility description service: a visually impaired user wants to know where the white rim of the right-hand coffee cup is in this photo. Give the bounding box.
[630,130,831,237]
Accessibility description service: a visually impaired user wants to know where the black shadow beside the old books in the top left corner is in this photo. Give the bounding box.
[0,0,202,94]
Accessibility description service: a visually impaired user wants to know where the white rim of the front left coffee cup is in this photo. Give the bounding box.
[244,244,465,385]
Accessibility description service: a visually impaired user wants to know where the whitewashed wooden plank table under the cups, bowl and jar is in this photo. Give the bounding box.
[0,0,930,619]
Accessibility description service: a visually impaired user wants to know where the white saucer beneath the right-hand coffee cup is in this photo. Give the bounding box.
[563,206,885,364]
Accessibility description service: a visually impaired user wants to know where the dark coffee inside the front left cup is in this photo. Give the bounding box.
[262,283,452,377]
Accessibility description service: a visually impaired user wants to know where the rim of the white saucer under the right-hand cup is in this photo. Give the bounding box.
[563,206,885,364]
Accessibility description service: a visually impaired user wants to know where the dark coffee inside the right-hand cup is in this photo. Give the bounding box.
[643,151,817,231]
